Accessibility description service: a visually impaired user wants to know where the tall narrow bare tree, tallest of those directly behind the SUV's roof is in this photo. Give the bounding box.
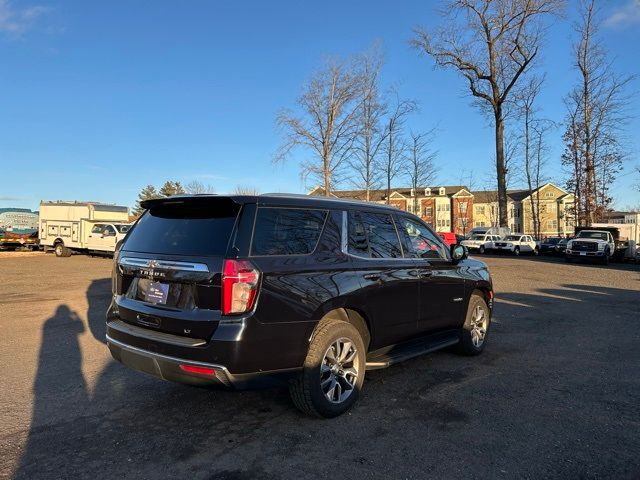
[348,45,387,201]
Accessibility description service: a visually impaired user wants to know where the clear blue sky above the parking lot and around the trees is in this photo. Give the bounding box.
[0,0,640,209]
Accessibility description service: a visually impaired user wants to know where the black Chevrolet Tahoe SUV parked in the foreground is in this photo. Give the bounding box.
[107,194,493,417]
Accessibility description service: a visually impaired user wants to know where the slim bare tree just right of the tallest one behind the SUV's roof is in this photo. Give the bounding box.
[381,92,416,204]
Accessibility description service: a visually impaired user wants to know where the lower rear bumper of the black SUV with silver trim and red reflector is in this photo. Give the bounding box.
[106,334,299,389]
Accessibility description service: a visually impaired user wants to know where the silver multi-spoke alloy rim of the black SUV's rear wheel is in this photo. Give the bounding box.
[320,337,360,403]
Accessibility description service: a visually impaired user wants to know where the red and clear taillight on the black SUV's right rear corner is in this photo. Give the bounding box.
[222,260,260,315]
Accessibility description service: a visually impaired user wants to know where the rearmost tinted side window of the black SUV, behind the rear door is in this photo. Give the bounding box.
[251,207,327,255]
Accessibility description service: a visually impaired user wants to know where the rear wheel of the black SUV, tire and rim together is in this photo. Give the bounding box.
[289,320,367,418]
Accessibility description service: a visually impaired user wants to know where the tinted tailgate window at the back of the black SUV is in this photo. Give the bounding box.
[123,204,239,256]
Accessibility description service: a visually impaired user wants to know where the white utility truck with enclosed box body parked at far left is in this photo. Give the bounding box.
[38,201,131,257]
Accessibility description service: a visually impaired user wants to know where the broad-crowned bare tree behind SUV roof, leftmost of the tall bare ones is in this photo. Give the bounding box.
[274,59,362,196]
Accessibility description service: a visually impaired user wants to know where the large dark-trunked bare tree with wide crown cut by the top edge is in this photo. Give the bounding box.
[412,0,564,226]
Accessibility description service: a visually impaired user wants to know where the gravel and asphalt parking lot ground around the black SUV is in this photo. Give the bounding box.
[0,254,640,479]
